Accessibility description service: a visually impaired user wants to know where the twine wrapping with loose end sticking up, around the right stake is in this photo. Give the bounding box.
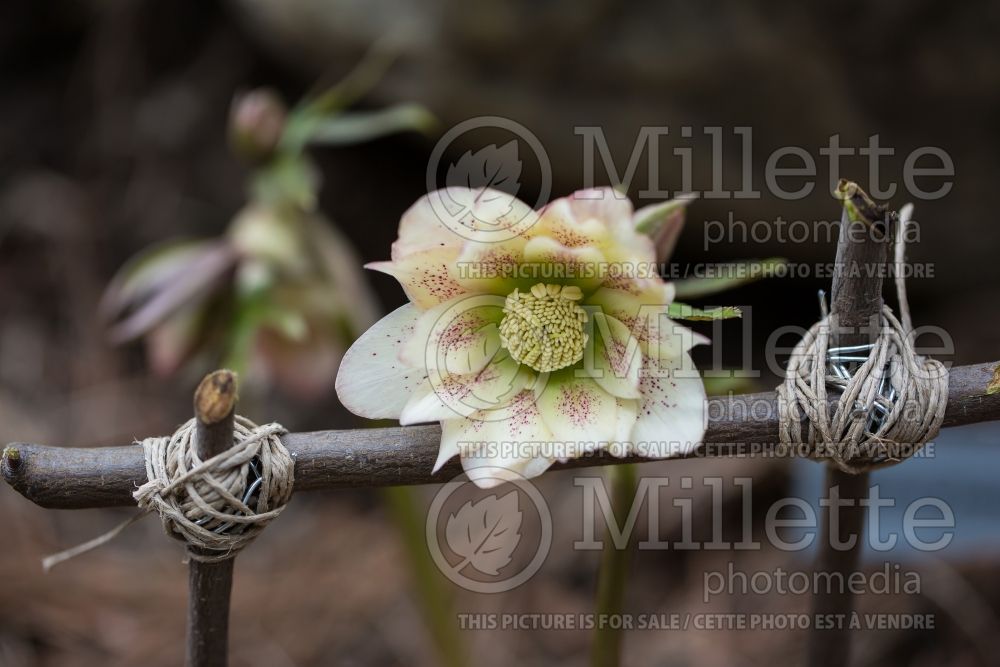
[778,206,948,474]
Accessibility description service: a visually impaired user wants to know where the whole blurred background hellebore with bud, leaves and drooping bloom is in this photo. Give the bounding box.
[101,54,434,399]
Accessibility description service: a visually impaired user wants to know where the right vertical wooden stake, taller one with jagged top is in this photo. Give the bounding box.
[809,181,891,667]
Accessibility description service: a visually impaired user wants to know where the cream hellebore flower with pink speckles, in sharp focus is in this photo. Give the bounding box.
[337,188,707,487]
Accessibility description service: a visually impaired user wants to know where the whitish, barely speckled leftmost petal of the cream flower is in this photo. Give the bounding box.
[336,304,427,419]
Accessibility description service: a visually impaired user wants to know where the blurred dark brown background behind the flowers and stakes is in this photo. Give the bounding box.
[0,0,1000,665]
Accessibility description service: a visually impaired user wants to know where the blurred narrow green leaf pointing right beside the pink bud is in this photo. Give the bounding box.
[285,104,437,146]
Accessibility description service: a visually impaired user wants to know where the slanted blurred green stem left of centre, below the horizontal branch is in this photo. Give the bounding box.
[382,486,467,667]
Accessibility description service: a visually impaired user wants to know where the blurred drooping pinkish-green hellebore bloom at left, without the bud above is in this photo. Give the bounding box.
[101,204,377,400]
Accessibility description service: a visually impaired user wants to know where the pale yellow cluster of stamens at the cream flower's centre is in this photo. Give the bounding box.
[500,283,587,373]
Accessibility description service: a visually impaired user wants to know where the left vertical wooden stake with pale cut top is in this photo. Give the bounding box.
[187,370,236,667]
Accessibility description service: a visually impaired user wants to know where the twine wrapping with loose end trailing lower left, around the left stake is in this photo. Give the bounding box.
[42,415,295,570]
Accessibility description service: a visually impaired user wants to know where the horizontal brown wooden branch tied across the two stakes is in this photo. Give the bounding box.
[2,362,1000,509]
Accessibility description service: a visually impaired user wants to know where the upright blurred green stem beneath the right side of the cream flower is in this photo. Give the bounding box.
[590,465,637,667]
